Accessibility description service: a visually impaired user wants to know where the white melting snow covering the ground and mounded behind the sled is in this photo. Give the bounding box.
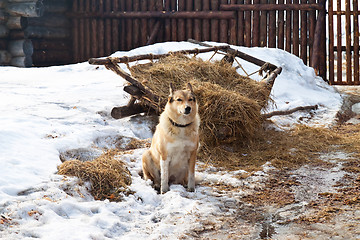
[0,42,342,239]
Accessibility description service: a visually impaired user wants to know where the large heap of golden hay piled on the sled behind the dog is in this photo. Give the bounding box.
[130,55,269,148]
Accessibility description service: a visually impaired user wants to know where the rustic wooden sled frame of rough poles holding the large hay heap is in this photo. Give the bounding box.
[89,39,282,119]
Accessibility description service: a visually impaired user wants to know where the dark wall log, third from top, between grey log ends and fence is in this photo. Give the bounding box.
[24,26,71,39]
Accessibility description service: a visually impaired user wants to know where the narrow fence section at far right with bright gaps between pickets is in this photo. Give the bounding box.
[329,0,360,85]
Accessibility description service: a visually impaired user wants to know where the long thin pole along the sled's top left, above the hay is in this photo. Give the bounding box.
[89,45,229,65]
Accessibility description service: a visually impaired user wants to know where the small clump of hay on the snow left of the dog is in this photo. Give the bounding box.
[58,150,131,201]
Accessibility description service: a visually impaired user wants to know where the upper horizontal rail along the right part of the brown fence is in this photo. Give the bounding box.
[220,3,323,11]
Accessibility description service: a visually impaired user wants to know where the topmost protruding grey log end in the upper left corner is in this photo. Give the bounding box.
[6,1,44,17]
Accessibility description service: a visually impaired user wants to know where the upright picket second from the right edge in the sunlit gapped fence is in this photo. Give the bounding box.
[345,0,353,84]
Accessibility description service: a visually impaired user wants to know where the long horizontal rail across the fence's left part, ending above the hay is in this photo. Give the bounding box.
[67,11,235,19]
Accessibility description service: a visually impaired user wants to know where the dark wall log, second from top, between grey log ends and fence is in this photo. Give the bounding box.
[27,13,70,28]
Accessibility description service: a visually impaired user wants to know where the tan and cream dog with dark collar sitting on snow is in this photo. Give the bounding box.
[142,83,200,194]
